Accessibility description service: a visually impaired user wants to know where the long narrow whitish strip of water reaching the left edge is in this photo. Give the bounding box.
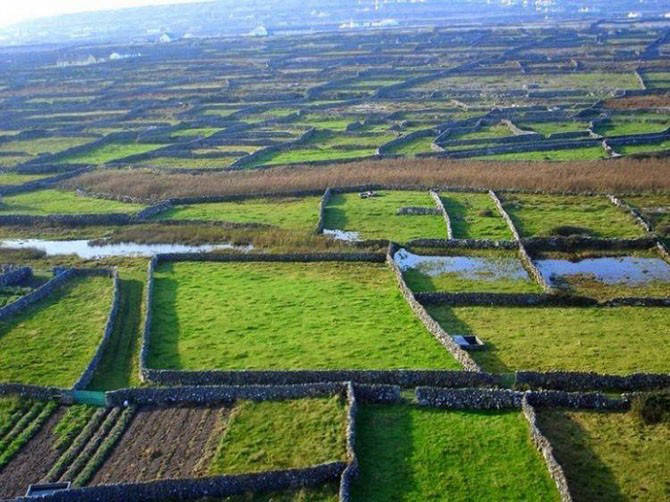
[0,239,251,259]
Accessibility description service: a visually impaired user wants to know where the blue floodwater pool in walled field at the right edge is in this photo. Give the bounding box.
[535,256,670,284]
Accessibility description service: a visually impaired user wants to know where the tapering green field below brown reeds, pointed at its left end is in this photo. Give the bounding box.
[159,197,320,232]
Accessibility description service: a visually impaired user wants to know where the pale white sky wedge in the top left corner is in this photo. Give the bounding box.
[0,0,215,26]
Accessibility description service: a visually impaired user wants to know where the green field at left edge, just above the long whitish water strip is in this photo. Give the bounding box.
[0,189,143,216]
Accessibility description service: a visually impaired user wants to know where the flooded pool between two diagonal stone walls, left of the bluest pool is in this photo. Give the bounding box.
[393,249,529,281]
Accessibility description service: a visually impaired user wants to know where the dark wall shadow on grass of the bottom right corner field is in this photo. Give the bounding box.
[538,411,627,502]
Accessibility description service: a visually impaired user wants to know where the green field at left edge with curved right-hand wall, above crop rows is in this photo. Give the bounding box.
[0,277,113,387]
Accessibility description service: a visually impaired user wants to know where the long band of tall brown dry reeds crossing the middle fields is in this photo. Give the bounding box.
[66,158,670,201]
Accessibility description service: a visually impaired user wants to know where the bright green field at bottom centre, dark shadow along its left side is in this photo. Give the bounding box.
[352,405,559,502]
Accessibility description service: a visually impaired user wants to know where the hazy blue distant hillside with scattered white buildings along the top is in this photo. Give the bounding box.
[0,0,670,45]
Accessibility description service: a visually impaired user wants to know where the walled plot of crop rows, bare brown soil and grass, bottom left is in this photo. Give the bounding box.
[0,395,345,498]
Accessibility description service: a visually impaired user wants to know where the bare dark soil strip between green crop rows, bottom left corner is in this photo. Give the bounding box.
[0,407,66,497]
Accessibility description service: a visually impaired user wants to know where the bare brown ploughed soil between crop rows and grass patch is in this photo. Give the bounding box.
[89,407,228,485]
